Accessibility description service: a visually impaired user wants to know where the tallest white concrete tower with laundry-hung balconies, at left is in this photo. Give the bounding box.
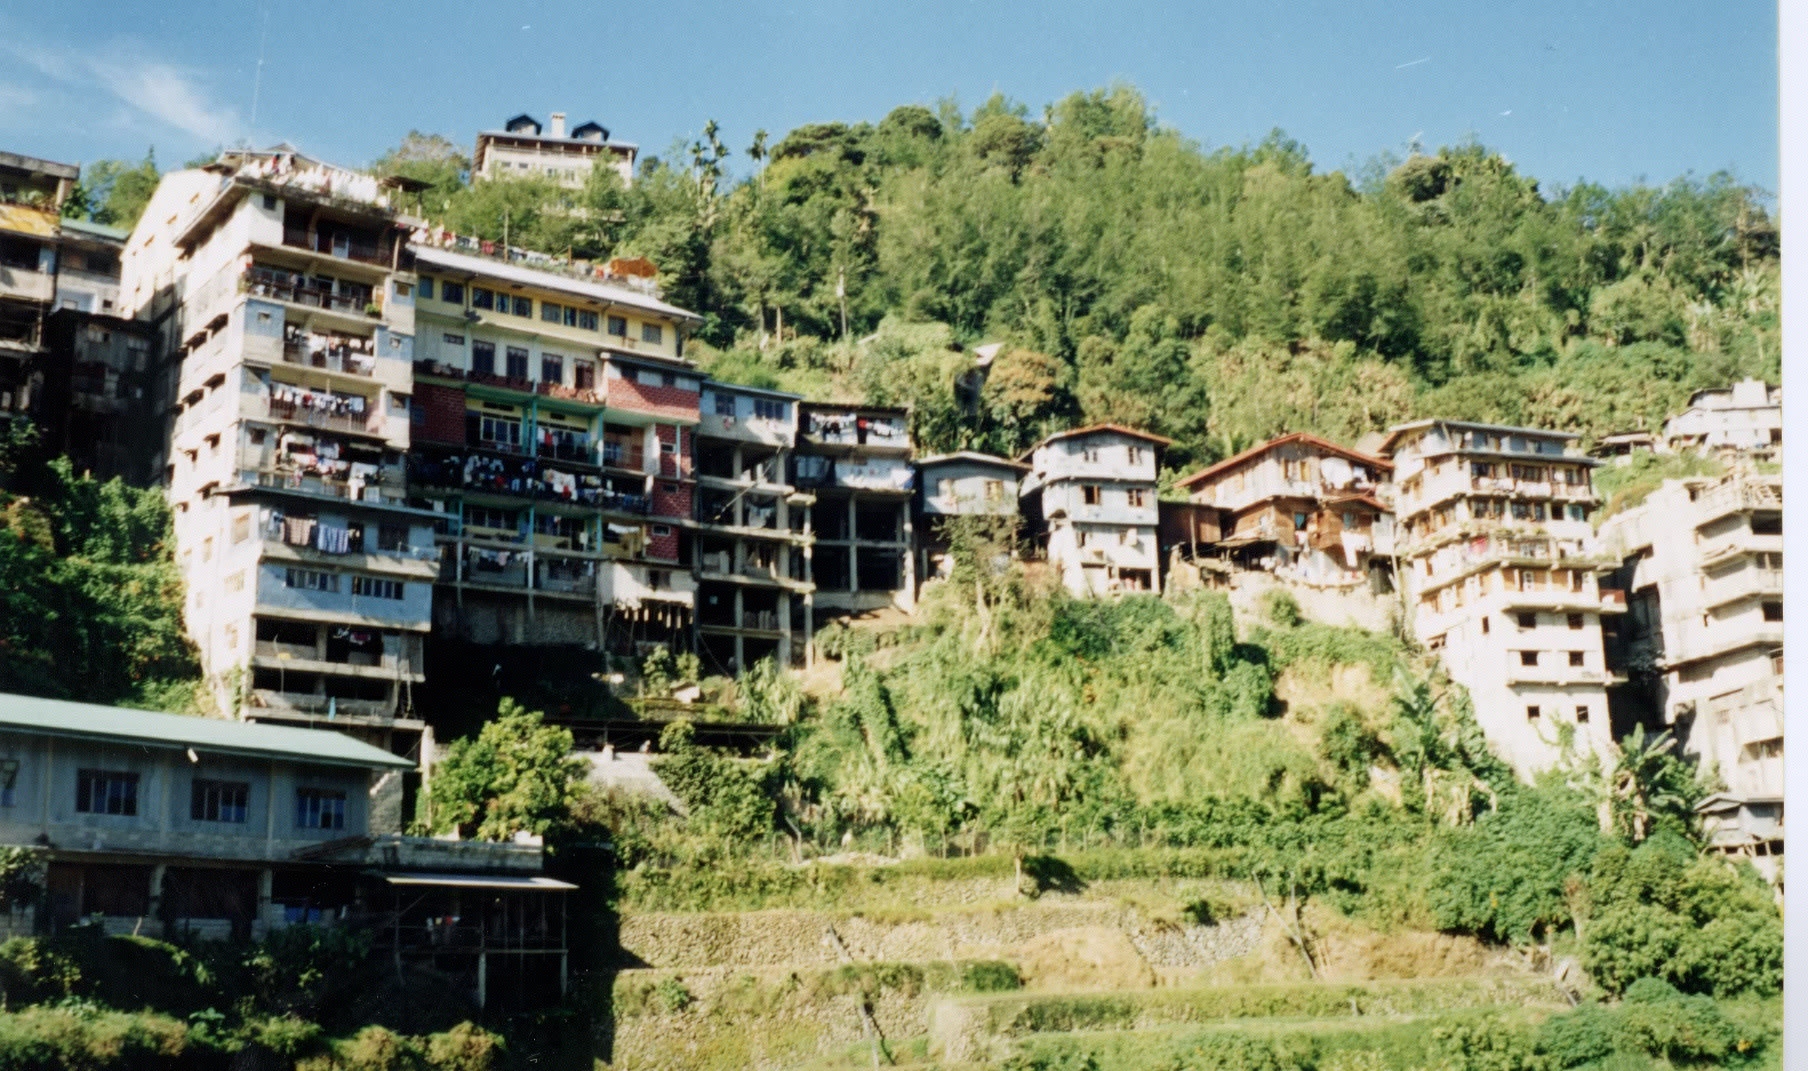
[121,147,436,747]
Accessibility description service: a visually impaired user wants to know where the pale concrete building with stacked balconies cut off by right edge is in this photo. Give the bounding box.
[1602,473,1783,877]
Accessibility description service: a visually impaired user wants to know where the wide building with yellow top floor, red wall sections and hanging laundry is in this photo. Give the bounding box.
[409,244,703,653]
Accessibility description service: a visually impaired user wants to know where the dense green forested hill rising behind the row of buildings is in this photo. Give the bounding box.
[325,87,1779,467]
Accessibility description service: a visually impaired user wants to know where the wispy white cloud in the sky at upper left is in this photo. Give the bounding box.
[0,42,244,145]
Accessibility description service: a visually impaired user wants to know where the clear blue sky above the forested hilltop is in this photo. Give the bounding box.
[0,0,1777,190]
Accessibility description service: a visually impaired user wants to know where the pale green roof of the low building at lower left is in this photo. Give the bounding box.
[0,693,414,769]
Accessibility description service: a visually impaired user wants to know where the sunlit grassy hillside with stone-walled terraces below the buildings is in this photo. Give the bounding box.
[586,559,1781,1071]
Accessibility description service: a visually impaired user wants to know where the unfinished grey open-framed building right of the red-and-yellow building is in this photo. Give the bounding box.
[694,382,815,673]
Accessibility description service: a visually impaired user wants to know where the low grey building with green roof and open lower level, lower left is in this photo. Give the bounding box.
[0,695,573,1008]
